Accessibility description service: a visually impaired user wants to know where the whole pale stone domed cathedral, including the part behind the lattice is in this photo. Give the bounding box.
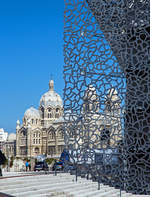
[16,80,122,158]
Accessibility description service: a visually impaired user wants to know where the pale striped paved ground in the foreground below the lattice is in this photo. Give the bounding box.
[0,172,148,197]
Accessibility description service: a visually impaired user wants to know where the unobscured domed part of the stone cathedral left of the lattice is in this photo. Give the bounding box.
[16,80,64,158]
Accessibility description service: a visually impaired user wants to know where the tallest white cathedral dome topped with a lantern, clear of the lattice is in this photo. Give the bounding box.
[40,80,63,108]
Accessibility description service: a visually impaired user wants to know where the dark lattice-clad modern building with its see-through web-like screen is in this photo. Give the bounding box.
[64,0,150,195]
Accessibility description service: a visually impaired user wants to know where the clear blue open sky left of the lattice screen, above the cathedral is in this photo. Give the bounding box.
[0,0,64,133]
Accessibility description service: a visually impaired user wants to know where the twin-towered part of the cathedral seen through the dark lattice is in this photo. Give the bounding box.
[65,85,122,150]
